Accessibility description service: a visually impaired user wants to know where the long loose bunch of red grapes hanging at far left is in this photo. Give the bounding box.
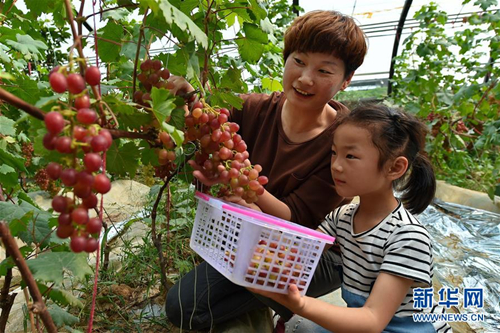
[43,66,113,252]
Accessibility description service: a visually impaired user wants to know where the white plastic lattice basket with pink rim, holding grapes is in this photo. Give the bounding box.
[190,192,335,295]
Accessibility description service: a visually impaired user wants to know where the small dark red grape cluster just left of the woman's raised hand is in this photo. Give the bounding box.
[133,59,170,107]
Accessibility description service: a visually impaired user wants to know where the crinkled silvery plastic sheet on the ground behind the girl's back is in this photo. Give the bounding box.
[419,200,500,332]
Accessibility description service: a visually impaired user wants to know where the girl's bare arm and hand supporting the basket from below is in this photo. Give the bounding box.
[251,273,413,332]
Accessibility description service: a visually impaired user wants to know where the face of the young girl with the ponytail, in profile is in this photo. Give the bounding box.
[331,124,392,197]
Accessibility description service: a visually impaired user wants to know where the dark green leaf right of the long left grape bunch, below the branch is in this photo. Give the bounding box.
[106,140,140,177]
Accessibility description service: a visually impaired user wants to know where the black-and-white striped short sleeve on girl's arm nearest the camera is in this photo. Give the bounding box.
[380,223,433,286]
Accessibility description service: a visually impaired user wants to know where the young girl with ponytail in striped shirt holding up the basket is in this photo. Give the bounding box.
[252,105,451,332]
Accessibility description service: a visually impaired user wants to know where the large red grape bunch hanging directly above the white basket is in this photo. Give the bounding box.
[185,101,268,203]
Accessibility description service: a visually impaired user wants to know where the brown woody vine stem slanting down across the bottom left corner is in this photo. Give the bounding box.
[0,221,57,333]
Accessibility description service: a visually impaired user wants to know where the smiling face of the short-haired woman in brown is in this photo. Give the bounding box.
[283,52,352,111]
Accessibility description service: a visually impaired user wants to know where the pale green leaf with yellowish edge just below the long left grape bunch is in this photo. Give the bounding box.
[26,252,92,285]
